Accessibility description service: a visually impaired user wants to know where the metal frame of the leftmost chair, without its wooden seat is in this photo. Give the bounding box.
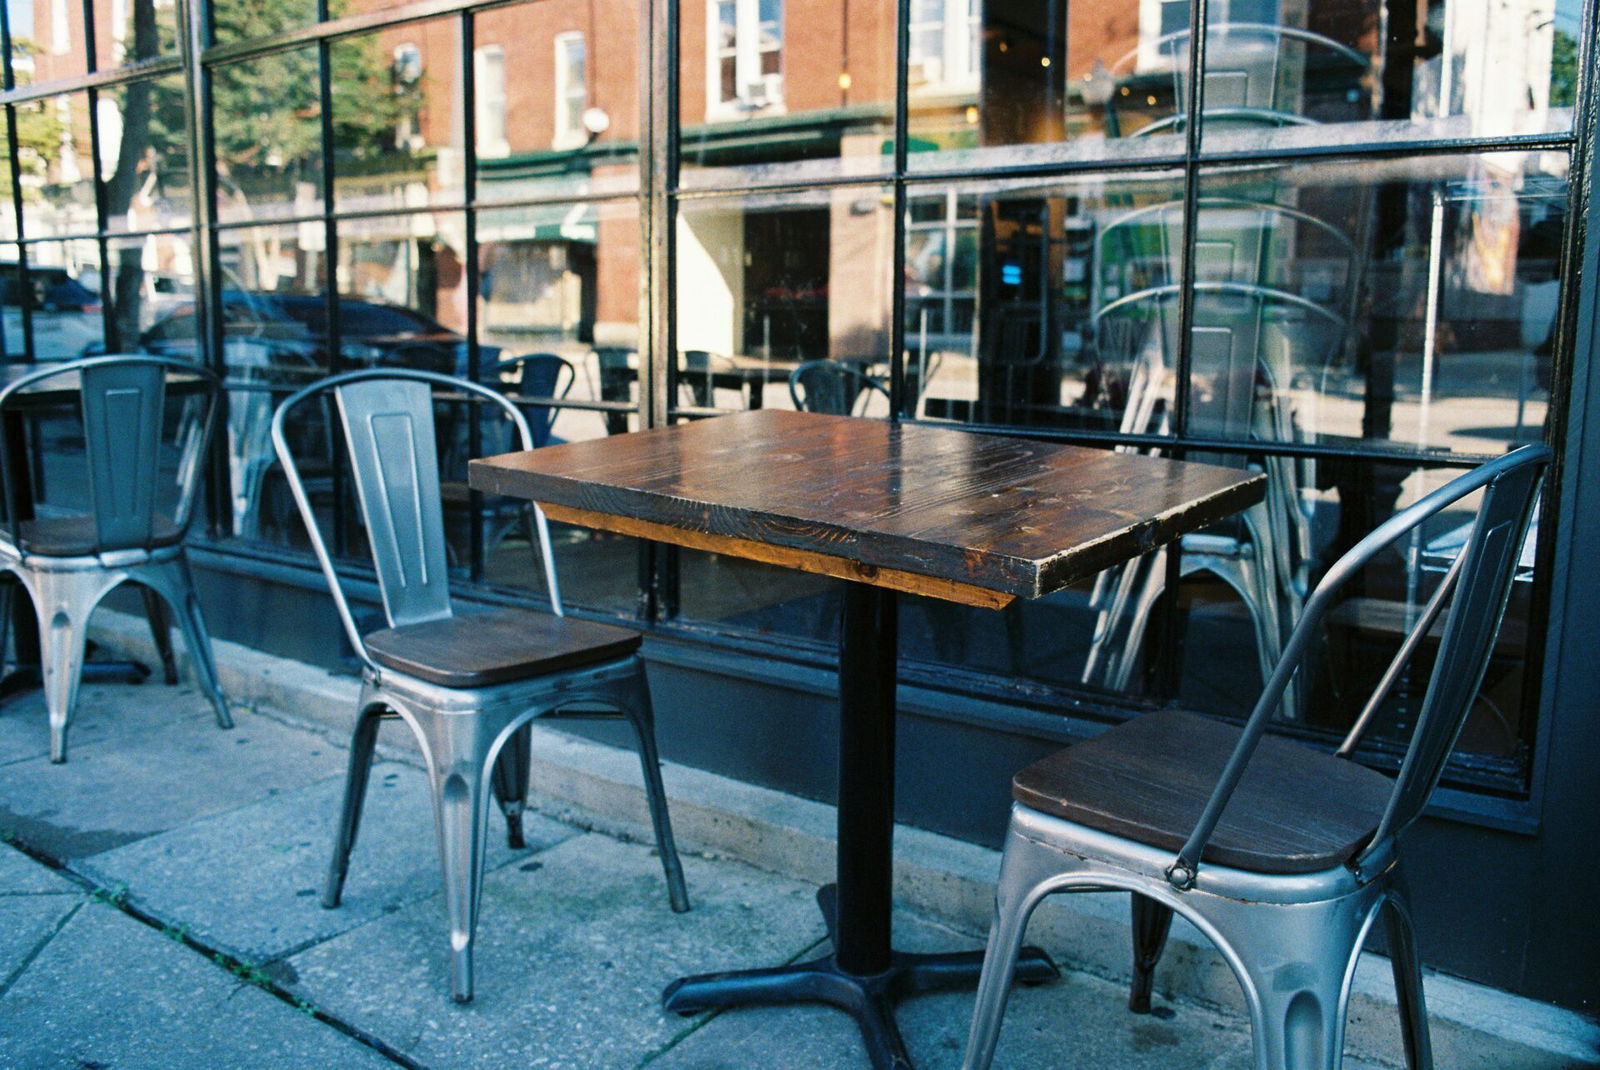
[0,353,234,763]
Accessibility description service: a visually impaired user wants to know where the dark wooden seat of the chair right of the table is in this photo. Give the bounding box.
[1011,710,1394,873]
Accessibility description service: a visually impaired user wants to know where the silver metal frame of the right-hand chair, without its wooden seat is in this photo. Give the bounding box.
[963,446,1552,1070]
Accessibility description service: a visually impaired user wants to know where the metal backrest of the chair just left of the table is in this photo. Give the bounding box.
[272,368,562,672]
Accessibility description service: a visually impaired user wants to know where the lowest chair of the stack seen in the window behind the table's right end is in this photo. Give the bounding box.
[1083,283,1346,694]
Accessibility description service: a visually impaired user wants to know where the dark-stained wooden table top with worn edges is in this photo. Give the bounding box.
[469,409,1266,608]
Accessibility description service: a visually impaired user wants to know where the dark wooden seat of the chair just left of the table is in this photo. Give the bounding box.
[363,609,643,688]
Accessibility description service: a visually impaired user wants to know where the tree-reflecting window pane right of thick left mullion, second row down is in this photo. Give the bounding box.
[211,48,322,222]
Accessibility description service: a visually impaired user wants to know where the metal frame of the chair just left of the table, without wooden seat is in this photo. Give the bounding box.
[272,368,688,1003]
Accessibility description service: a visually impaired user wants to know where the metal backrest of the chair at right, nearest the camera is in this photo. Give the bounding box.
[1166,445,1552,888]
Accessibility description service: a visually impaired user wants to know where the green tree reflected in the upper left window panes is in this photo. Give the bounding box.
[106,0,421,345]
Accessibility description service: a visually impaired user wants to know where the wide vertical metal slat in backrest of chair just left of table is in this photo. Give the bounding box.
[334,379,450,627]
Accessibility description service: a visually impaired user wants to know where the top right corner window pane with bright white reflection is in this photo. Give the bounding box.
[1190,0,1581,150]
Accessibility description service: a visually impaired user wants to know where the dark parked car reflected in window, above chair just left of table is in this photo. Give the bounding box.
[139,291,499,374]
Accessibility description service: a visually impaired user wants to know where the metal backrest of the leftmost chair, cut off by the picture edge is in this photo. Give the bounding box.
[0,355,219,553]
